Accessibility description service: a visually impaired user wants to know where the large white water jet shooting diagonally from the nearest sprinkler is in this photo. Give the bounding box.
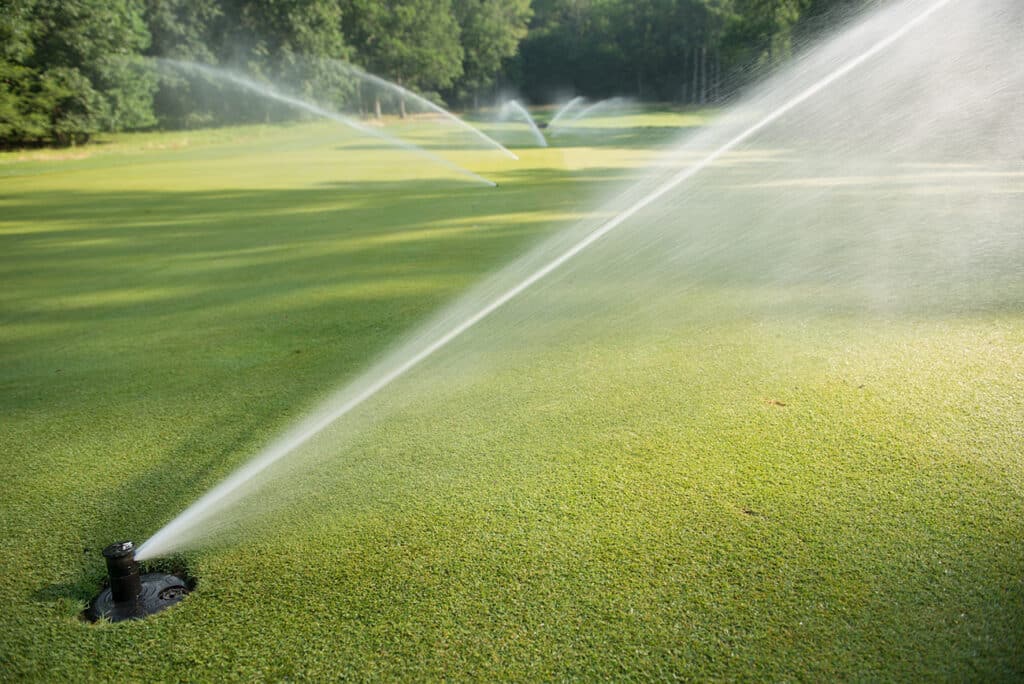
[138,0,1020,559]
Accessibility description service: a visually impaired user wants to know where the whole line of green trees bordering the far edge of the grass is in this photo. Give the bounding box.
[0,0,865,146]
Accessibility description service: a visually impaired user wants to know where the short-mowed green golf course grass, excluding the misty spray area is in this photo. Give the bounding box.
[0,113,1024,681]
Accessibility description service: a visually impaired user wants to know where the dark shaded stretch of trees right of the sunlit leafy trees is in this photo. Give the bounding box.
[505,0,867,104]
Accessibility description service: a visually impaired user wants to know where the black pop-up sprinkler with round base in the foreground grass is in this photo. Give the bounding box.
[86,542,188,623]
